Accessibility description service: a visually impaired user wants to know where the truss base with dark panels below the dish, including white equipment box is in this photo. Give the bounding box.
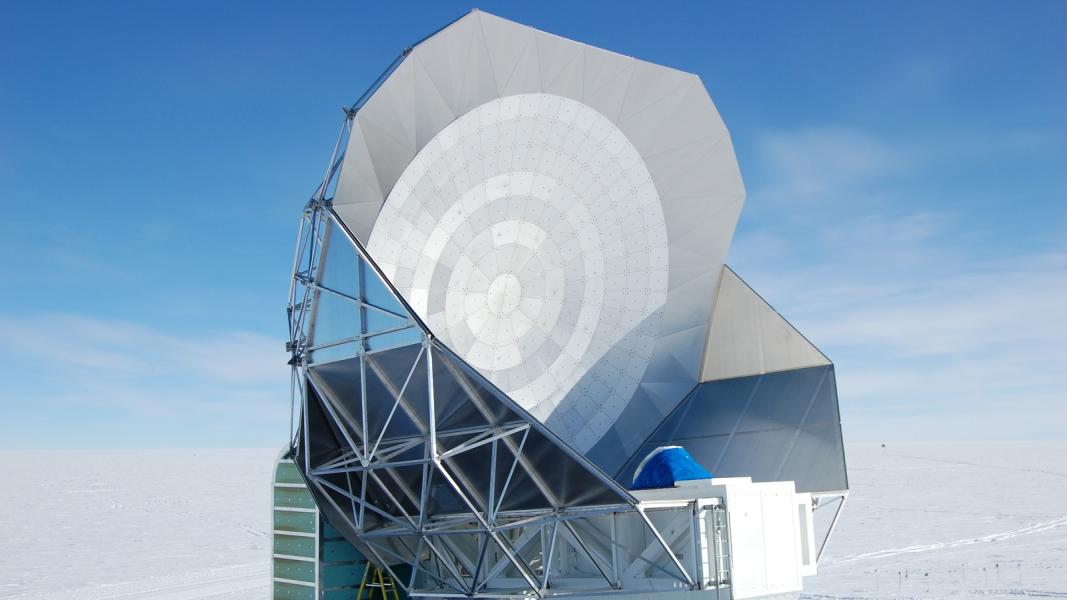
[289,202,817,599]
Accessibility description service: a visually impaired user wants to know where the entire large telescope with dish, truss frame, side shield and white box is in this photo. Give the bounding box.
[288,11,848,598]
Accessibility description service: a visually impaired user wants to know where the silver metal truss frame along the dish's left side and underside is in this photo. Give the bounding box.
[287,138,729,598]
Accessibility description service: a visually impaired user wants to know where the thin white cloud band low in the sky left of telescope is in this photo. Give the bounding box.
[0,314,289,416]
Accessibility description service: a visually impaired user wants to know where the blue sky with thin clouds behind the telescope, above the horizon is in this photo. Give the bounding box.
[0,0,1067,448]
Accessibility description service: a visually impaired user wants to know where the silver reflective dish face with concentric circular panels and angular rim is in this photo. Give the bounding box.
[334,12,744,460]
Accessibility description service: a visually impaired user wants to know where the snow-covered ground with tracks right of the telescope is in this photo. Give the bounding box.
[805,443,1067,599]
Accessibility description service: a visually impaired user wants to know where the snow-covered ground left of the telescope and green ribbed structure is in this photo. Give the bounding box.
[0,449,277,600]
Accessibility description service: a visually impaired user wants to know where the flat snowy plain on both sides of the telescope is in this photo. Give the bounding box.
[0,443,1067,600]
